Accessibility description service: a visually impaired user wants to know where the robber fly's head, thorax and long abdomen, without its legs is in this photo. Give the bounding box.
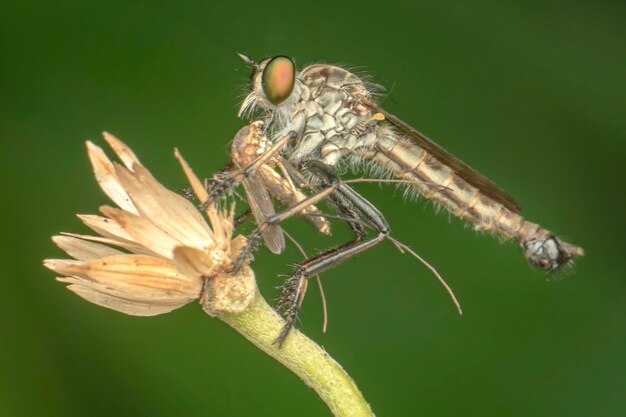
[239,54,584,271]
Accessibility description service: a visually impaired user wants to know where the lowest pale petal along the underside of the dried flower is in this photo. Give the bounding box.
[62,283,192,317]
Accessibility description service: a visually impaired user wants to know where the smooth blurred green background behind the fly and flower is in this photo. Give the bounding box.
[0,0,626,417]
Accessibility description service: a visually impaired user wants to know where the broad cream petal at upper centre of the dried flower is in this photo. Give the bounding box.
[116,165,213,248]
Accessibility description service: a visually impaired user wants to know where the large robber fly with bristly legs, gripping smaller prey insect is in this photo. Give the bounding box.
[205,55,583,344]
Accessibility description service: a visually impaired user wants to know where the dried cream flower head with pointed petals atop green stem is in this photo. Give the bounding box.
[44,133,256,316]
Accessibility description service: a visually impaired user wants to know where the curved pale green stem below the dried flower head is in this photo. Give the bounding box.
[215,289,374,417]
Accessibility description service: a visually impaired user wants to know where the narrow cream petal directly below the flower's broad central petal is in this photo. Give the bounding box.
[100,206,183,258]
